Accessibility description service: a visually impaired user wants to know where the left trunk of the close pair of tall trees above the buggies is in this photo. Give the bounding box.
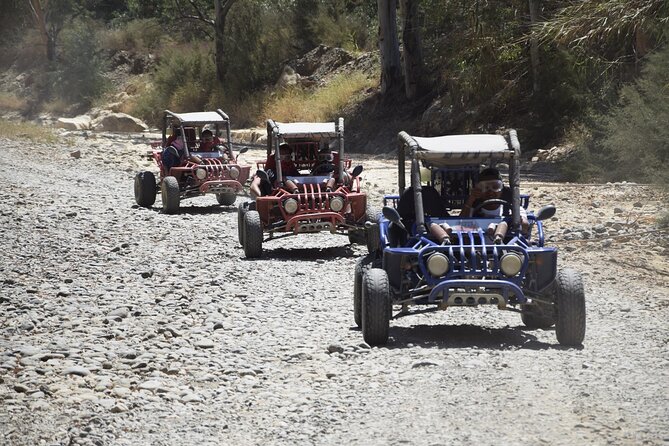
[377,0,402,95]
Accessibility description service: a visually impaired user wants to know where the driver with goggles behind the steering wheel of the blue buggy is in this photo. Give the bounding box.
[460,167,529,233]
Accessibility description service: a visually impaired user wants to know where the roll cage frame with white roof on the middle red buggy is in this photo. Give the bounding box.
[267,118,344,184]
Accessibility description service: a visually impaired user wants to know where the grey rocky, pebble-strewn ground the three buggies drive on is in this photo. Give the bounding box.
[0,130,669,445]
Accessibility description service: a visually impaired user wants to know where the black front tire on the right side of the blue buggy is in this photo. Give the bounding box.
[554,269,585,345]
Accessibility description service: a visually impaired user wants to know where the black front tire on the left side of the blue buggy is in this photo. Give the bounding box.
[362,268,392,345]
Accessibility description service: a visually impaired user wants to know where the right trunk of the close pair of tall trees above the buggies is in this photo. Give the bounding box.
[400,0,423,99]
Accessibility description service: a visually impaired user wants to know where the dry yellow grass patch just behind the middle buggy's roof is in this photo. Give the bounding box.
[264,73,377,122]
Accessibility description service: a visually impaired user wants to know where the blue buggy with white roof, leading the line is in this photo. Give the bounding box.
[353,130,585,345]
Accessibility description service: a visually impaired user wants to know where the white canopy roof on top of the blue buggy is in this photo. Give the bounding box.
[404,133,514,166]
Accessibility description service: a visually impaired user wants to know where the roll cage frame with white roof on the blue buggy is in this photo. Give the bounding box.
[397,129,520,234]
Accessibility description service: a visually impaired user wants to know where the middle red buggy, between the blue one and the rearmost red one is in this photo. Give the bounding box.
[238,118,368,258]
